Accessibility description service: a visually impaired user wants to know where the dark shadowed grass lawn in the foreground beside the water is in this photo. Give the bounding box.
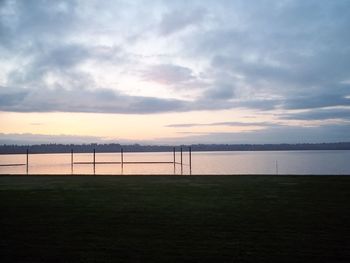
[0,176,350,262]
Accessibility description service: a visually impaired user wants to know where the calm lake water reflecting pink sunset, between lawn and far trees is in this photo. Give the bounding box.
[0,151,350,175]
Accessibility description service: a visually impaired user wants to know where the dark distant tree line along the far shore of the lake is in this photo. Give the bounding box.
[0,142,350,154]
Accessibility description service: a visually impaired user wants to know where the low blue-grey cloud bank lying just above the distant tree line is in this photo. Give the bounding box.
[0,125,350,145]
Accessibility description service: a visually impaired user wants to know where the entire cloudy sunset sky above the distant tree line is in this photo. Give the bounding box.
[0,0,350,144]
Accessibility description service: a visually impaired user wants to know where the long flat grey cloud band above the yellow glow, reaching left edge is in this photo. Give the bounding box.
[0,88,186,114]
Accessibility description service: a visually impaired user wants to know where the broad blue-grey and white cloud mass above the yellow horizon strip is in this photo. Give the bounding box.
[0,0,350,127]
